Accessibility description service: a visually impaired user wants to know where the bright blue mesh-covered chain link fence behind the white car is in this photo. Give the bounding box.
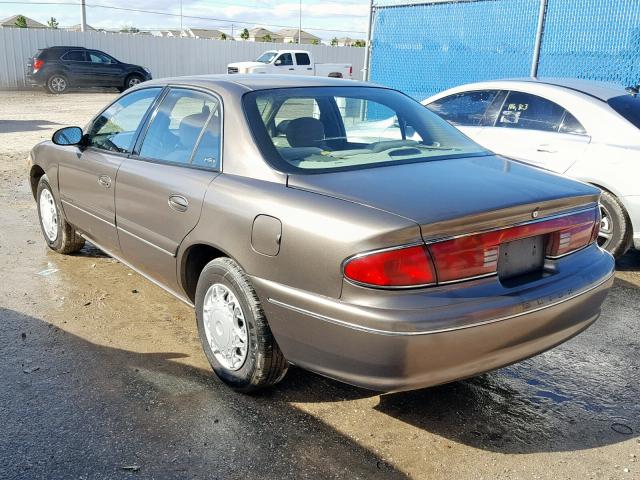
[370,0,640,100]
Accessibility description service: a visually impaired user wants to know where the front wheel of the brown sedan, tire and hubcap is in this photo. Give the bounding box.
[36,175,84,254]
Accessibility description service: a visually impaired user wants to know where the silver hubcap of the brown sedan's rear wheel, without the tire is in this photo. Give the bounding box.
[202,283,247,370]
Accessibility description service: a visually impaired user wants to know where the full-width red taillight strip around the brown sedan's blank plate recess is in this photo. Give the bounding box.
[344,208,600,287]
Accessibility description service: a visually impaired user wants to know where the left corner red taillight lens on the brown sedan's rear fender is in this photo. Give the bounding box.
[344,245,436,288]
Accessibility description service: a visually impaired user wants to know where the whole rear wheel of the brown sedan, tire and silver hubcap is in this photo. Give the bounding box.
[195,257,288,393]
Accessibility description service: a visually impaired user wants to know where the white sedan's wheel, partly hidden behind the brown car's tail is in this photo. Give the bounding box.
[598,191,633,258]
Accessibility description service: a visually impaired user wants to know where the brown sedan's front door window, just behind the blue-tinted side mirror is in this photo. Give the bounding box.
[87,88,162,153]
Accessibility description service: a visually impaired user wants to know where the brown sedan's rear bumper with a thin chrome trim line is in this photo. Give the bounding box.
[254,246,613,391]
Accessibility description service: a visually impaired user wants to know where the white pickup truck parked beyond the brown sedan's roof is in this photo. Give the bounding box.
[227,50,353,79]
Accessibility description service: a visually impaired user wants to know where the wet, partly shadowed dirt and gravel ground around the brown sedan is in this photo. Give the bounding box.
[0,91,640,480]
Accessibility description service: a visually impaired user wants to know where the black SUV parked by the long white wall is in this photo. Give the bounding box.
[27,47,151,93]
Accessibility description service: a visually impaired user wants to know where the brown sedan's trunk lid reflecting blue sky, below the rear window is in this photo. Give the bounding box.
[288,155,599,240]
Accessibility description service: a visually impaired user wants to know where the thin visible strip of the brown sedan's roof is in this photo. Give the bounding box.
[140,74,370,90]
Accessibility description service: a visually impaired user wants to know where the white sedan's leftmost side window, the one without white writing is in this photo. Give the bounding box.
[427,90,498,126]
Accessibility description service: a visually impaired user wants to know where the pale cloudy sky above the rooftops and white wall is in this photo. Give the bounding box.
[0,0,369,39]
